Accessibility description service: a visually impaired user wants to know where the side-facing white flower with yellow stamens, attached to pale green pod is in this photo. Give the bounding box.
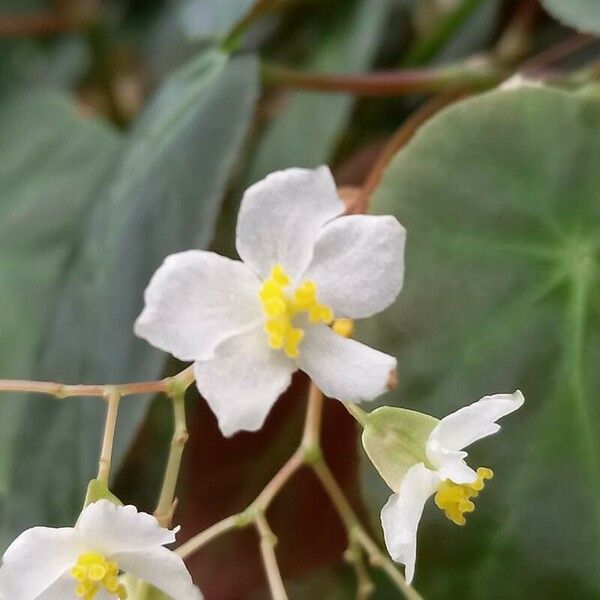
[381,391,525,583]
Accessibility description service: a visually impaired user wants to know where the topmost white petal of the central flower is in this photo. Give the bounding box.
[236,167,345,279]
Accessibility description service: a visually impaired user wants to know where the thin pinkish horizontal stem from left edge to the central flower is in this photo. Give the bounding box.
[0,366,194,400]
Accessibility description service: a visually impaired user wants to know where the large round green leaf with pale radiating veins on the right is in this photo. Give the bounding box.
[363,87,600,600]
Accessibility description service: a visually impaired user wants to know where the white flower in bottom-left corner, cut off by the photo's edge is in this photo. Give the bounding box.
[0,500,201,600]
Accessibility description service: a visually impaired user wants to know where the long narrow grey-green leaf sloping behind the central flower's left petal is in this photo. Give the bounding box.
[2,51,258,540]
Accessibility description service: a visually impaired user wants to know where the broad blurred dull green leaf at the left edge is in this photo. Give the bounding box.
[0,93,119,500]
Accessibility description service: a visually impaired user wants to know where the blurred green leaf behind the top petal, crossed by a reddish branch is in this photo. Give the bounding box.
[248,0,388,182]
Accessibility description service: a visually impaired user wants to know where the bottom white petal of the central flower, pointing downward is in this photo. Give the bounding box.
[194,326,296,437]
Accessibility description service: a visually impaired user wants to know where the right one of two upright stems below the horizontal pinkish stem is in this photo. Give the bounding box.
[154,387,189,527]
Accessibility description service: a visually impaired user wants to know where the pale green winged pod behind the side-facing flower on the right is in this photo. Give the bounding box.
[362,406,439,492]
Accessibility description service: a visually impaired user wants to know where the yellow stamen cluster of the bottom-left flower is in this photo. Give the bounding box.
[71,552,127,600]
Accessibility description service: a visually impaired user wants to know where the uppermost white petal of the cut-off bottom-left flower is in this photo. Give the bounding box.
[76,500,177,556]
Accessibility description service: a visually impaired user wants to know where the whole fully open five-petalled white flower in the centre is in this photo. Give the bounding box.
[135,167,405,435]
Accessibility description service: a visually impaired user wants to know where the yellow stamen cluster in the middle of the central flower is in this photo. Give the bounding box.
[259,264,333,358]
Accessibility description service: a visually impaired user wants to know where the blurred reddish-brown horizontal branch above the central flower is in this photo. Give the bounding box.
[262,60,509,97]
